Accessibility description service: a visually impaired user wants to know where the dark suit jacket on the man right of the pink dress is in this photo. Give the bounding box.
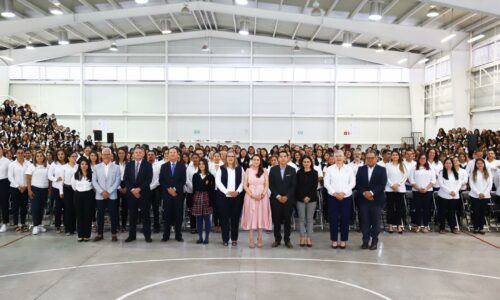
[269,165,296,205]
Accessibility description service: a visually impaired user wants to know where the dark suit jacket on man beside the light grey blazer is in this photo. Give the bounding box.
[123,159,153,198]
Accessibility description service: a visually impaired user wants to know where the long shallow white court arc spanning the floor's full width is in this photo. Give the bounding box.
[0,257,500,280]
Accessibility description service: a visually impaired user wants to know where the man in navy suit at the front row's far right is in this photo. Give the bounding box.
[356,151,387,250]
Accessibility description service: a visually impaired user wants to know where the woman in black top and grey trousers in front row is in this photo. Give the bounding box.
[295,155,323,247]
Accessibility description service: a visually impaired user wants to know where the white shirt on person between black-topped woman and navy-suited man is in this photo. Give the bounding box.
[324,164,356,198]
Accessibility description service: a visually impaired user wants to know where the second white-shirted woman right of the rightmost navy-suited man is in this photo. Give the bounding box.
[410,154,436,233]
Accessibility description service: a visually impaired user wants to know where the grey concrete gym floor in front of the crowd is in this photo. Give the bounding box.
[0,230,500,300]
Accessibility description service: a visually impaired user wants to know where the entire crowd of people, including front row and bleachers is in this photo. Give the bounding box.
[0,100,500,249]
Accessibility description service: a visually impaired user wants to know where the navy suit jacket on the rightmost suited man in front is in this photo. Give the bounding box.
[356,165,387,205]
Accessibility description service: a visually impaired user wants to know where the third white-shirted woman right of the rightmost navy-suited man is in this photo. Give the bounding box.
[437,157,462,233]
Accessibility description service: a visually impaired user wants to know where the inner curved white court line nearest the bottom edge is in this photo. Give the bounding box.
[116,271,391,300]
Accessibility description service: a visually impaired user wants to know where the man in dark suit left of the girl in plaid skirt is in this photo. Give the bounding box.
[159,148,186,242]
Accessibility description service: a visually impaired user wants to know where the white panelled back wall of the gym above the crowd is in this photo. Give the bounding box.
[10,39,411,146]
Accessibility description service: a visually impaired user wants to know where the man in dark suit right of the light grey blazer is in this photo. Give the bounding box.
[123,147,153,243]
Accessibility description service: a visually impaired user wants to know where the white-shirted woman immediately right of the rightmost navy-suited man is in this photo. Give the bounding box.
[385,151,408,234]
